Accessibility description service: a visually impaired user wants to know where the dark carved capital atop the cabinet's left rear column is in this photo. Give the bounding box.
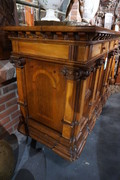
[10,56,26,68]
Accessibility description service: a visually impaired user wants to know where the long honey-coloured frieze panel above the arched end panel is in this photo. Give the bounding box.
[12,40,69,60]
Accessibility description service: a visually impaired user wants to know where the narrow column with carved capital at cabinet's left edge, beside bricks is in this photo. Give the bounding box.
[10,56,29,135]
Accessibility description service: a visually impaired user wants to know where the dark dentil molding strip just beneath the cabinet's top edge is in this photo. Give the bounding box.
[8,30,120,41]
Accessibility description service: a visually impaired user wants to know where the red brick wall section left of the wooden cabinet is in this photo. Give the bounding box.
[0,82,20,137]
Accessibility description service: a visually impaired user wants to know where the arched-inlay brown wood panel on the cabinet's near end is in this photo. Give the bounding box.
[25,60,66,132]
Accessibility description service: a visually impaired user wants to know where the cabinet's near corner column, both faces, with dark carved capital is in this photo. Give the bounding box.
[62,67,92,139]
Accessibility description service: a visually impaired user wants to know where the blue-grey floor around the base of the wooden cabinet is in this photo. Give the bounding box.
[6,93,120,180]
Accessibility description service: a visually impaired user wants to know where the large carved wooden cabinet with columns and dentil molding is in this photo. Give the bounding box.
[4,26,120,161]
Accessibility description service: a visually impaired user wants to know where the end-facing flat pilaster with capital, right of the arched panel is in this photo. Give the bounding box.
[62,67,82,139]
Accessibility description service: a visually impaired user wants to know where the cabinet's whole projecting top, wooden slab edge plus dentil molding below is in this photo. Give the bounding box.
[0,25,120,41]
